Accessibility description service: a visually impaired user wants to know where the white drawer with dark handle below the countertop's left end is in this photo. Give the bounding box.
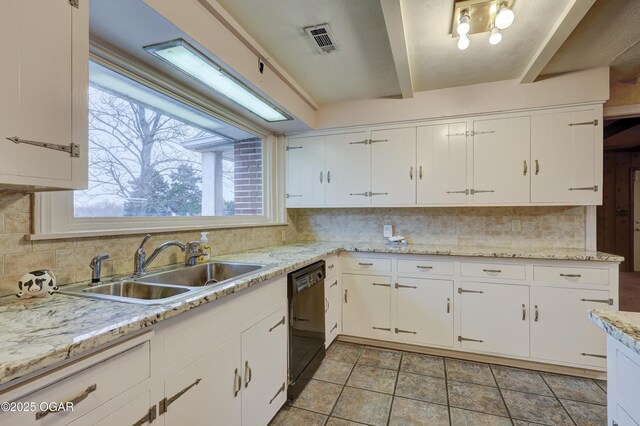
[5,342,150,425]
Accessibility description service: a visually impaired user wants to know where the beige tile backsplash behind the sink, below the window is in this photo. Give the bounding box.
[0,193,287,296]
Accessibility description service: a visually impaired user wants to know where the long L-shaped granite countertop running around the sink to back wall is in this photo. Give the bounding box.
[0,242,623,385]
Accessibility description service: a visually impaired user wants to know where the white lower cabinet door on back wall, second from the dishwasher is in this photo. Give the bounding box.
[394,278,453,347]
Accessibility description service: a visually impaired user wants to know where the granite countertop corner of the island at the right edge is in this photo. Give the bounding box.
[589,309,640,355]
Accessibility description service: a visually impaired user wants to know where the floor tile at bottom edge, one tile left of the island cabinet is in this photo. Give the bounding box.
[502,390,573,426]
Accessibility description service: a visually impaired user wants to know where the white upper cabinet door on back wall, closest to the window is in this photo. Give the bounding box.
[287,136,326,207]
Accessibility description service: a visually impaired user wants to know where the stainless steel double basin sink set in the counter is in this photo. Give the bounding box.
[60,262,267,305]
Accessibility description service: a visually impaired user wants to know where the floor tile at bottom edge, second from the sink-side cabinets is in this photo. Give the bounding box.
[331,387,392,426]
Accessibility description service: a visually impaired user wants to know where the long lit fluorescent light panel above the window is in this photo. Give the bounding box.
[144,39,291,122]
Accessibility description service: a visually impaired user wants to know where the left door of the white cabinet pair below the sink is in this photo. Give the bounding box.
[160,336,242,426]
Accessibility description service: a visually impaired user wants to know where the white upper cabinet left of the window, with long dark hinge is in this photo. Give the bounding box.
[0,0,89,190]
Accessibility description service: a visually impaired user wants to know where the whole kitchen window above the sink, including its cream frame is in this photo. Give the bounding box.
[34,56,284,239]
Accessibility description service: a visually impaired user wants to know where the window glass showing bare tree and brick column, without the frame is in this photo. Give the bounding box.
[74,63,262,217]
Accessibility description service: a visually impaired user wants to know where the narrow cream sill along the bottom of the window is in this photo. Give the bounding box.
[25,222,287,241]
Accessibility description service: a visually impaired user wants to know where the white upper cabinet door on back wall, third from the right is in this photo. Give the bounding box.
[417,123,468,205]
